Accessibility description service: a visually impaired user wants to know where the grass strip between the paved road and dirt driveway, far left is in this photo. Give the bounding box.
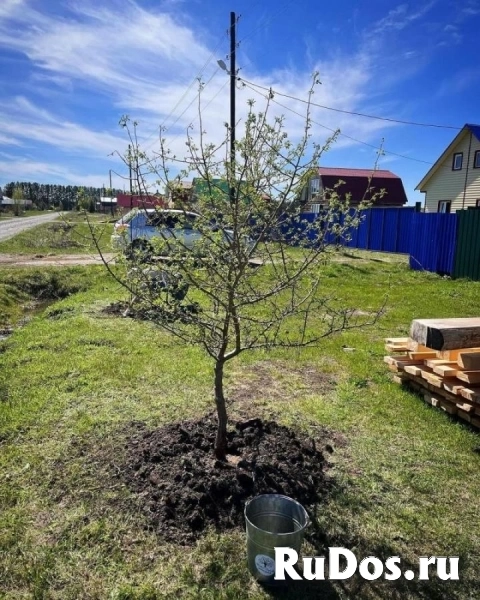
[0,212,113,255]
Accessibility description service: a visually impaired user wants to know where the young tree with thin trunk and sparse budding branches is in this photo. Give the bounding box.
[105,78,378,460]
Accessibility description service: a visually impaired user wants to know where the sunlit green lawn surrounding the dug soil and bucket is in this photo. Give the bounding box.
[0,253,480,600]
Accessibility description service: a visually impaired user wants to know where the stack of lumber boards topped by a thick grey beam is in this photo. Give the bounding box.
[384,318,480,428]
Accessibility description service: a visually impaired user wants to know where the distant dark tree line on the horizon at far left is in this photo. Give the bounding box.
[3,181,122,210]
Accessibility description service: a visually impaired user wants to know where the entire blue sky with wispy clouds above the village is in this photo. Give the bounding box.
[0,0,480,202]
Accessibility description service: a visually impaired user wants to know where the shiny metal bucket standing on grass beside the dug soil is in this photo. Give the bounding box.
[245,494,309,584]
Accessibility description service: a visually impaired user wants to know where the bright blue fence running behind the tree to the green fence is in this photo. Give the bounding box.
[294,207,457,275]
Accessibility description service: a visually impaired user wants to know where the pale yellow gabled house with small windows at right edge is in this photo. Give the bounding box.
[415,123,480,213]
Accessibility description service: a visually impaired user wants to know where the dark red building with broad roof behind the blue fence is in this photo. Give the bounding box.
[300,167,408,212]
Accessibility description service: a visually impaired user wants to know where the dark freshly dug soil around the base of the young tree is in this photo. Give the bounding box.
[123,416,332,544]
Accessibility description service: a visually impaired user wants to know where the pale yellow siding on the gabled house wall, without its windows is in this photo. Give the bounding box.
[421,131,480,212]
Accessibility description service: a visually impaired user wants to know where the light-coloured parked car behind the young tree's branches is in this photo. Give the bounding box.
[111,208,254,254]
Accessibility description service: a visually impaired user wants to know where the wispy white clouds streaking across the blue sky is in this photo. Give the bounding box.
[0,0,434,185]
